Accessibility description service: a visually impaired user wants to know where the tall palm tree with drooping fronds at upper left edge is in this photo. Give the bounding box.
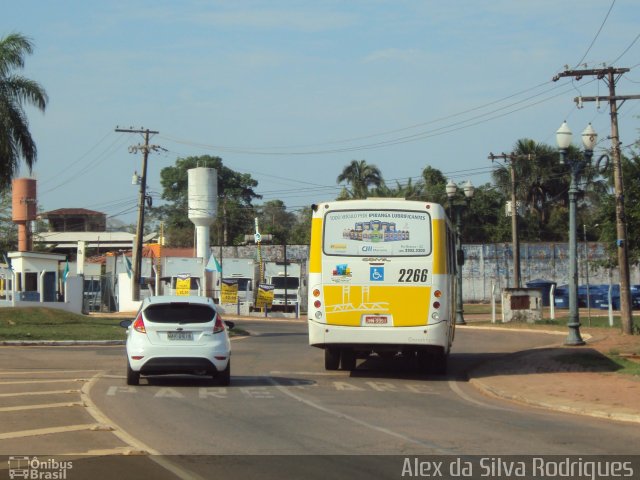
[0,33,48,190]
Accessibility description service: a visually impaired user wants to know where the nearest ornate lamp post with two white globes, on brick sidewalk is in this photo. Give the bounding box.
[556,122,598,346]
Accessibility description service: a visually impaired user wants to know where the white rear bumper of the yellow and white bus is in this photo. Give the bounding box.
[308,319,450,352]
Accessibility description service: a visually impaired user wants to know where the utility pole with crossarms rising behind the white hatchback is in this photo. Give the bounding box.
[116,127,164,301]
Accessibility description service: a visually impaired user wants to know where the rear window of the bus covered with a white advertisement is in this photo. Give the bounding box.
[322,210,431,257]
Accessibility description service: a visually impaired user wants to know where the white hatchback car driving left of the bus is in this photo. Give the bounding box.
[120,295,234,385]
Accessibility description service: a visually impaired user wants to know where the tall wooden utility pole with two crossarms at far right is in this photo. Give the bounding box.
[553,67,640,335]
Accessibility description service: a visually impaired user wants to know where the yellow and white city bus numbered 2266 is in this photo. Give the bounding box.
[308,198,456,374]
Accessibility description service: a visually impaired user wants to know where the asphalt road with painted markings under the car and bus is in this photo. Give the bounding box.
[0,321,640,480]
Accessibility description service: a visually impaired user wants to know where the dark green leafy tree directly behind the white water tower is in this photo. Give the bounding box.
[151,155,261,246]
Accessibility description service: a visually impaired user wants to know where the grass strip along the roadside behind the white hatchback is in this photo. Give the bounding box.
[0,307,249,341]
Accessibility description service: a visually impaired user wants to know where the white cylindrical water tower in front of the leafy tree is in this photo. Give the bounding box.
[187,167,218,262]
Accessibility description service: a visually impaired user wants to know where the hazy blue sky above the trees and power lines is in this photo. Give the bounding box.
[5,0,640,224]
